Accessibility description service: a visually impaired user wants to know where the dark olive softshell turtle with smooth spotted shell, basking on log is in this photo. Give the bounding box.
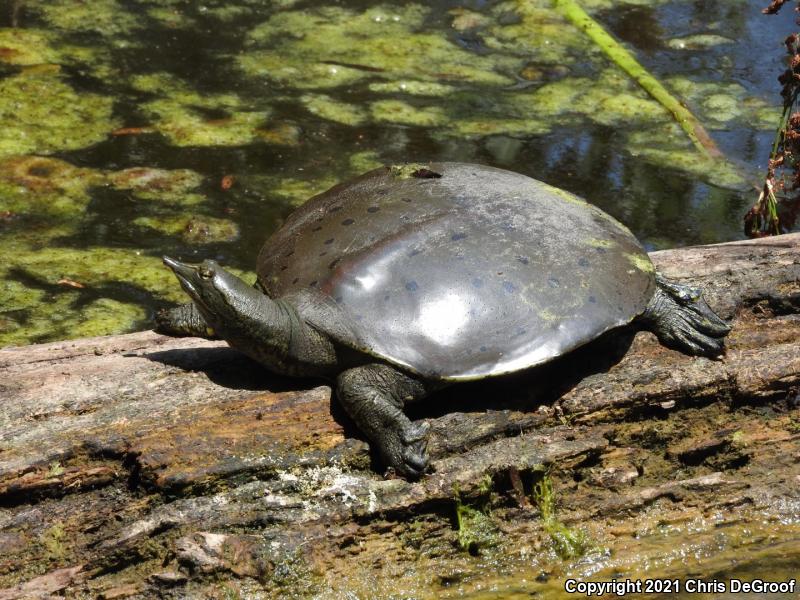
[157,163,729,477]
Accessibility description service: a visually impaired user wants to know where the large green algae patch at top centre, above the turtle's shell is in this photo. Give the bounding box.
[238,4,518,89]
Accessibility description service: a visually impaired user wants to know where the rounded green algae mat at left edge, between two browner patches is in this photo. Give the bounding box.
[0,71,119,157]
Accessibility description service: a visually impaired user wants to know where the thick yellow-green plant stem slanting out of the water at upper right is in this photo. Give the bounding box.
[553,0,723,158]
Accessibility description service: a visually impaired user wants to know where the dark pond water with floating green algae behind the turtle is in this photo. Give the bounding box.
[0,0,792,346]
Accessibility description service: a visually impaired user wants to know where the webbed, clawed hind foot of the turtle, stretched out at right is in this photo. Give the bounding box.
[641,273,731,357]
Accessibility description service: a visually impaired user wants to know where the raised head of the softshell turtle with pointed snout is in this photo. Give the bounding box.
[159,256,253,331]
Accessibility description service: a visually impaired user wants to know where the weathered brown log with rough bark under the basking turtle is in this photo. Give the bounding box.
[0,234,800,600]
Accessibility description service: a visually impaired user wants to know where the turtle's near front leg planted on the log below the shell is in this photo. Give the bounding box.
[336,364,429,478]
